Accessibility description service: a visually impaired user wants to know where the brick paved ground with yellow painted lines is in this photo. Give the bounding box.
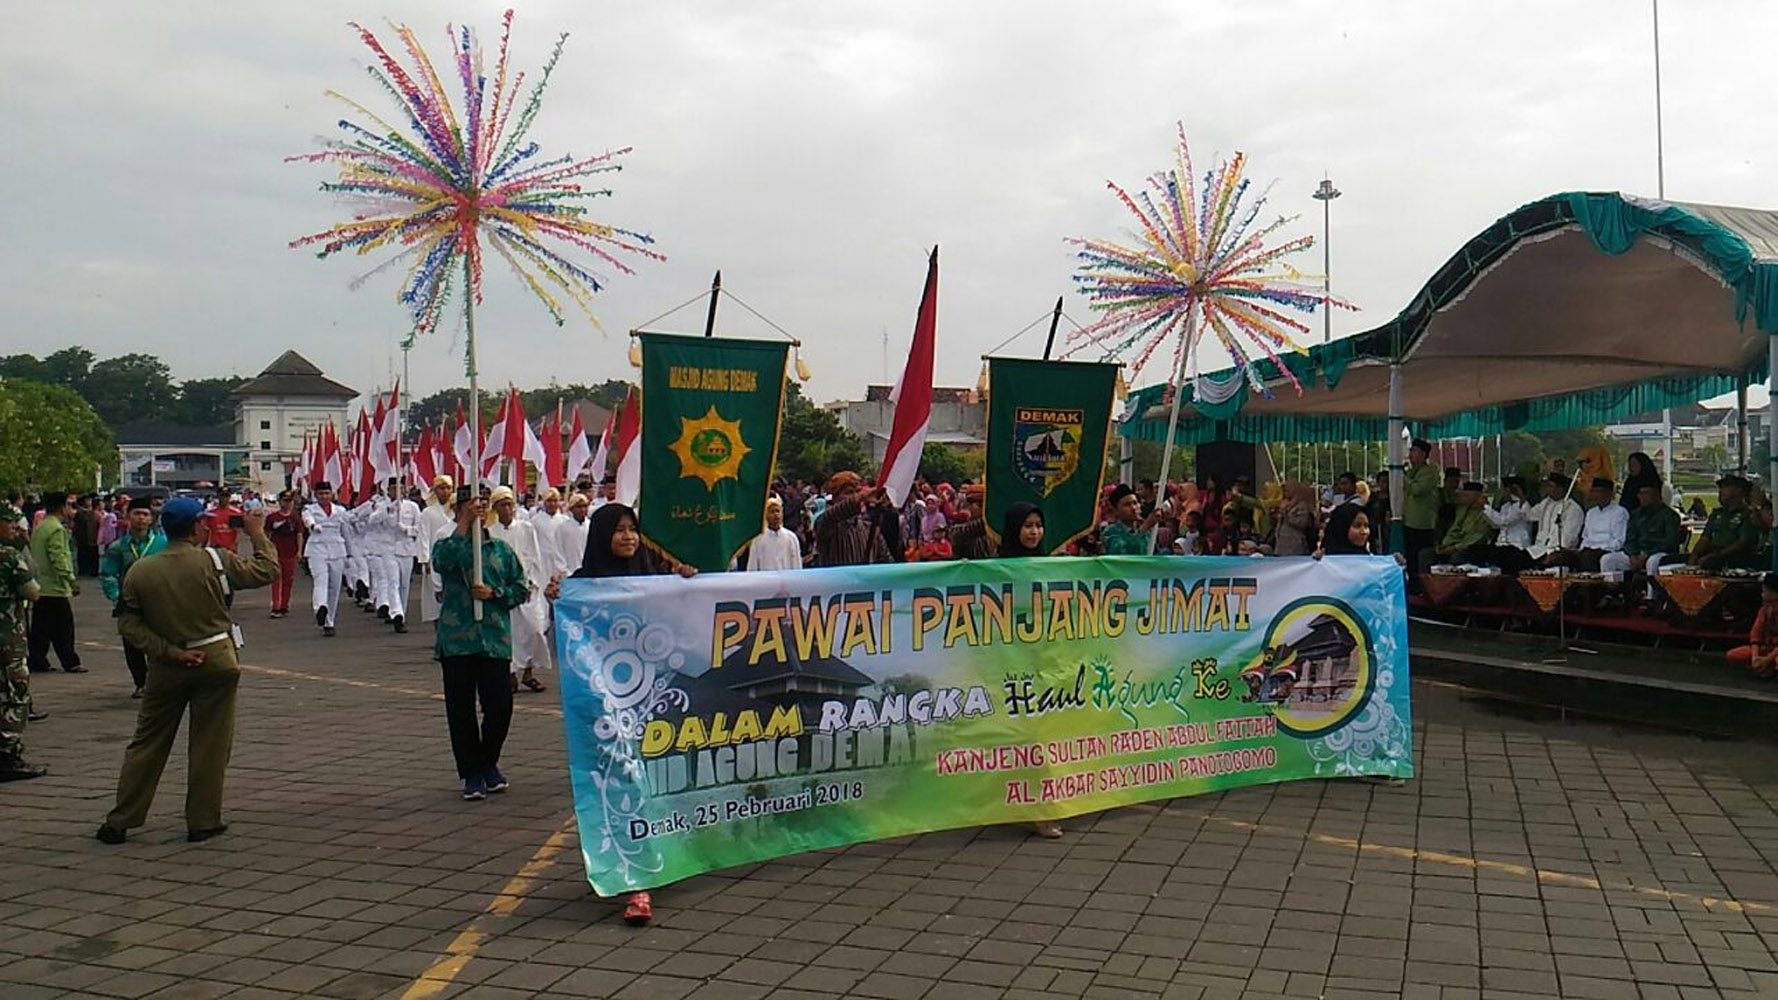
[0,584,1778,1000]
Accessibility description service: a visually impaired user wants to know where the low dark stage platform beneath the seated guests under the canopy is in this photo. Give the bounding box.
[1408,616,1778,740]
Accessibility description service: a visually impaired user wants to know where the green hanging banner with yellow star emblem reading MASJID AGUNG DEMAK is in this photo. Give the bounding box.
[638,333,789,571]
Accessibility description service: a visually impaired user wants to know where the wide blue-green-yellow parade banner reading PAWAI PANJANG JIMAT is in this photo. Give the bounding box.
[557,557,1414,895]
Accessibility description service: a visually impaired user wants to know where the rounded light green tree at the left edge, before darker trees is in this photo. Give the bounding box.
[0,379,117,491]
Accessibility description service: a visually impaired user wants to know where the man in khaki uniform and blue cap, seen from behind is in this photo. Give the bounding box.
[96,496,277,843]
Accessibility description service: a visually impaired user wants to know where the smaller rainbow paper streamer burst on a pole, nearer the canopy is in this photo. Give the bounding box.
[1069,125,1353,399]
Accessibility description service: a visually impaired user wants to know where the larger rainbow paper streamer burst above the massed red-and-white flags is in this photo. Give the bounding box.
[286,11,665,346]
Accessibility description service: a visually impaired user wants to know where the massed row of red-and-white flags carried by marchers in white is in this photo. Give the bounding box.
[292,383,642,504]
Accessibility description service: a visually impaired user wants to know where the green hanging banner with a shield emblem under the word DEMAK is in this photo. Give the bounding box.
[983,358,1118,552]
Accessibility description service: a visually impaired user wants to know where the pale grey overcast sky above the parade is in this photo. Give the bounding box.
[0,0,1778,400]
